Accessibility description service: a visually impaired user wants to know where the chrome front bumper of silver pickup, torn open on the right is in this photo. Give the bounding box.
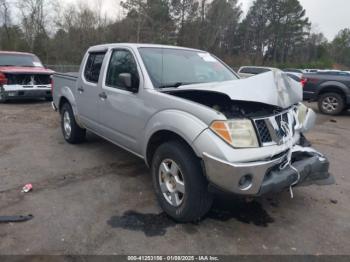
[203,146,334,196]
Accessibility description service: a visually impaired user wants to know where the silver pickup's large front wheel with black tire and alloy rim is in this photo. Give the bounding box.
[152,141,213,222]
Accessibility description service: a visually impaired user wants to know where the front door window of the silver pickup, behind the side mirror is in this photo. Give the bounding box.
[106,50,139,90]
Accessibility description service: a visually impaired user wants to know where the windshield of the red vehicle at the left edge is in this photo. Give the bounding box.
[0,54,43,67]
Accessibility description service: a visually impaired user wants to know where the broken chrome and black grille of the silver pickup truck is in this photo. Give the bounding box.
[254,110,295,146]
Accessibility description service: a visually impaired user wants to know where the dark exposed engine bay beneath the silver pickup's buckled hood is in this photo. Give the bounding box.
[166,90,283,119]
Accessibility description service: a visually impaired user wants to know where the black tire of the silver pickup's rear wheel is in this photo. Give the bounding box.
[61,103,86,144]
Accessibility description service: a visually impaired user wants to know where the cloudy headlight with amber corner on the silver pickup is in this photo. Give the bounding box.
[210,119,259,148]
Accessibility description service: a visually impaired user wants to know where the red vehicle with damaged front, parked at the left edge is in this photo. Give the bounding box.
[0,51,54,102]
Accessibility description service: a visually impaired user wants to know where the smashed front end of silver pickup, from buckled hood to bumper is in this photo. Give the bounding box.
[167,70,335,196]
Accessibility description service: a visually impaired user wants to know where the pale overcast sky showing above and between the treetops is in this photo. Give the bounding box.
[64,0,350,40]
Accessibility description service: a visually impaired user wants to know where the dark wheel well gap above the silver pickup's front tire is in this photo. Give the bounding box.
[146,130,196,166]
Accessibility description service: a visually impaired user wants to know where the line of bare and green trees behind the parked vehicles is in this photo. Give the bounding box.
[0,0,350,68]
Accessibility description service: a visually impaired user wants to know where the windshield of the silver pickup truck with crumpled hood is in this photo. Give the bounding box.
[139,47,238,88]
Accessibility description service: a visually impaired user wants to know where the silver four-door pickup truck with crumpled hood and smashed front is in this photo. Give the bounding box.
[53,44,334,222]
